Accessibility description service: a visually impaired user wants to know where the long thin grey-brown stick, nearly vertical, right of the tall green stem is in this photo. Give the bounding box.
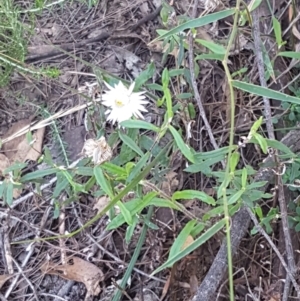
[252,9,299,301]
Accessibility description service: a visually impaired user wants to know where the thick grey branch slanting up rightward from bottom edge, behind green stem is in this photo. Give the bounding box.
[193,125,300,301]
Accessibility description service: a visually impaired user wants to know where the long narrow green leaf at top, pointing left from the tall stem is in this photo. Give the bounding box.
[151,9,235,43]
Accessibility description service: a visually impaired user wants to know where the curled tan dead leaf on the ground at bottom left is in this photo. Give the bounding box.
[41,256,104,296]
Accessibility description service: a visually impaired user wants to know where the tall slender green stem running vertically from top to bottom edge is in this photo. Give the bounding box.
[222,0,241,301]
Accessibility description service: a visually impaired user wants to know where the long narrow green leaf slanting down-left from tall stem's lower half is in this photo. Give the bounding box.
[152,219,225,275]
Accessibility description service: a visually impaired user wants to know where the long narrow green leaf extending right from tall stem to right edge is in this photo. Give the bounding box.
[232,79,300,104]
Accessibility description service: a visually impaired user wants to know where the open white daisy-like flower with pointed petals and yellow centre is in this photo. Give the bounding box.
[102,81,148,124]
